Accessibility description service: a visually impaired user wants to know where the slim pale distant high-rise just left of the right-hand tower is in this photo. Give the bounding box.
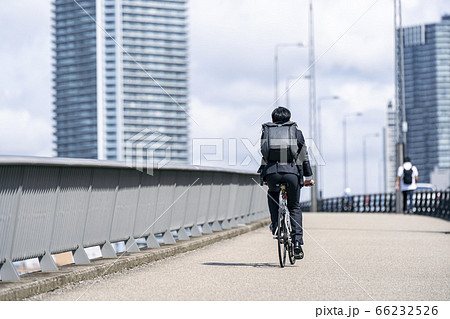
[383,102,398,193]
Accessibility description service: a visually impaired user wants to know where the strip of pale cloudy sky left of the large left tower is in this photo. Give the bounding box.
[0,0,53,156]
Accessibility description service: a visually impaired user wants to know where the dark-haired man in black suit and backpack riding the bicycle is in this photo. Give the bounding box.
[258,106,314,259]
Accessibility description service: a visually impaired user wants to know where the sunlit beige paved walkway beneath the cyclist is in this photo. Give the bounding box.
[34,213,450,300]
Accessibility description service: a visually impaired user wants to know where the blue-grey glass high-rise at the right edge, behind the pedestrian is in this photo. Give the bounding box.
[403,15,450,183]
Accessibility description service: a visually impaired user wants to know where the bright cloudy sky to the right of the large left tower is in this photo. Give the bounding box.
[191,0,445,196]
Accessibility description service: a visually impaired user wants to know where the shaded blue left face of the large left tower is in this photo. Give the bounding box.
[53,1,98,158]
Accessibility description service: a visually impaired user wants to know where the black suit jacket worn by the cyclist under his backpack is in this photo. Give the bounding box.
[258,129,312,181]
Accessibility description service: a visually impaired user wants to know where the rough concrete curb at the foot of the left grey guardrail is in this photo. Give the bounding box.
[0,218,269,301]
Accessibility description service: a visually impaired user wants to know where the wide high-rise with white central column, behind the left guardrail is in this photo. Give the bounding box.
[53,0,189,162]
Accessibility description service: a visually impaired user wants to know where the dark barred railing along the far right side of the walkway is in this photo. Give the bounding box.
[300,191,450,220]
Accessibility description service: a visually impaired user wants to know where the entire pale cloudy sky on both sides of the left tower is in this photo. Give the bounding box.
[0,0,450,199]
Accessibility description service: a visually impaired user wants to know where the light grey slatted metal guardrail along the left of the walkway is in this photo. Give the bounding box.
[0,157,268,281]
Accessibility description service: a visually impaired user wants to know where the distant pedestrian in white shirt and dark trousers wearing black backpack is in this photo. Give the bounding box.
[395,157,419,214]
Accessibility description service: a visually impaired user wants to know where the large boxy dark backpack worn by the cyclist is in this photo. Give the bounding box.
[261,121,298,163]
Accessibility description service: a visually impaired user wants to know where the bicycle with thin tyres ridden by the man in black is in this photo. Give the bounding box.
[276,184,295,268]
